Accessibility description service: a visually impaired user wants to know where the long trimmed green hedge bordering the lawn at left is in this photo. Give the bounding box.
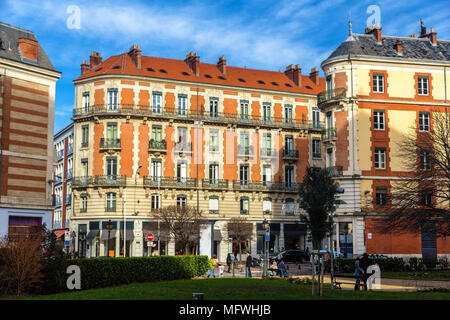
[43,256,209,293]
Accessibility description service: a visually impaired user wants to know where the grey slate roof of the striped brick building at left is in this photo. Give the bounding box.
[0,22,56,71]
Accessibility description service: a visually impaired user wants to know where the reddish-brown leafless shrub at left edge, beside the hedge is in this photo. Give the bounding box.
[0,229,45,295]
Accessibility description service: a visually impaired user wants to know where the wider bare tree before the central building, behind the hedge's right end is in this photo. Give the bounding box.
[153,205,205,254]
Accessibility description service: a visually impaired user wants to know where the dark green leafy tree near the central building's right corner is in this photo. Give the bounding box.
[299,167,339,249]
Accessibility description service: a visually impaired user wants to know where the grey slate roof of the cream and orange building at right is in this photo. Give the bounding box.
[322,34,450,63]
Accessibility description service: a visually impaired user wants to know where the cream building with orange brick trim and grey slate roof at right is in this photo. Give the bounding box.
[318,21,450,258]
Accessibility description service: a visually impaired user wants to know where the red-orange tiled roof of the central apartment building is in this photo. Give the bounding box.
[74,53,325,94]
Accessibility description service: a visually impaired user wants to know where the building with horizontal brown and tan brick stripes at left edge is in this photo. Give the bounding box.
[0,22,61,236]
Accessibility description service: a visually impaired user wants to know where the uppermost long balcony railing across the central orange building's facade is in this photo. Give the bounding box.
[73,104,323,130]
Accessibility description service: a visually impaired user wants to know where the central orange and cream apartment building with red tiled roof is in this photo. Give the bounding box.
[70,45,325,261]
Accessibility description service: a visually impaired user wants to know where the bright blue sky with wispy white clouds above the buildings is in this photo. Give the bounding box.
[0,0,450,132]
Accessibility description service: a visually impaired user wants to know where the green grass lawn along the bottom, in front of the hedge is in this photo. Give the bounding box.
[14,278,450,300]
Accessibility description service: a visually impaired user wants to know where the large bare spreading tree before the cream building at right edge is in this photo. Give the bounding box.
[379,111,450,235]
